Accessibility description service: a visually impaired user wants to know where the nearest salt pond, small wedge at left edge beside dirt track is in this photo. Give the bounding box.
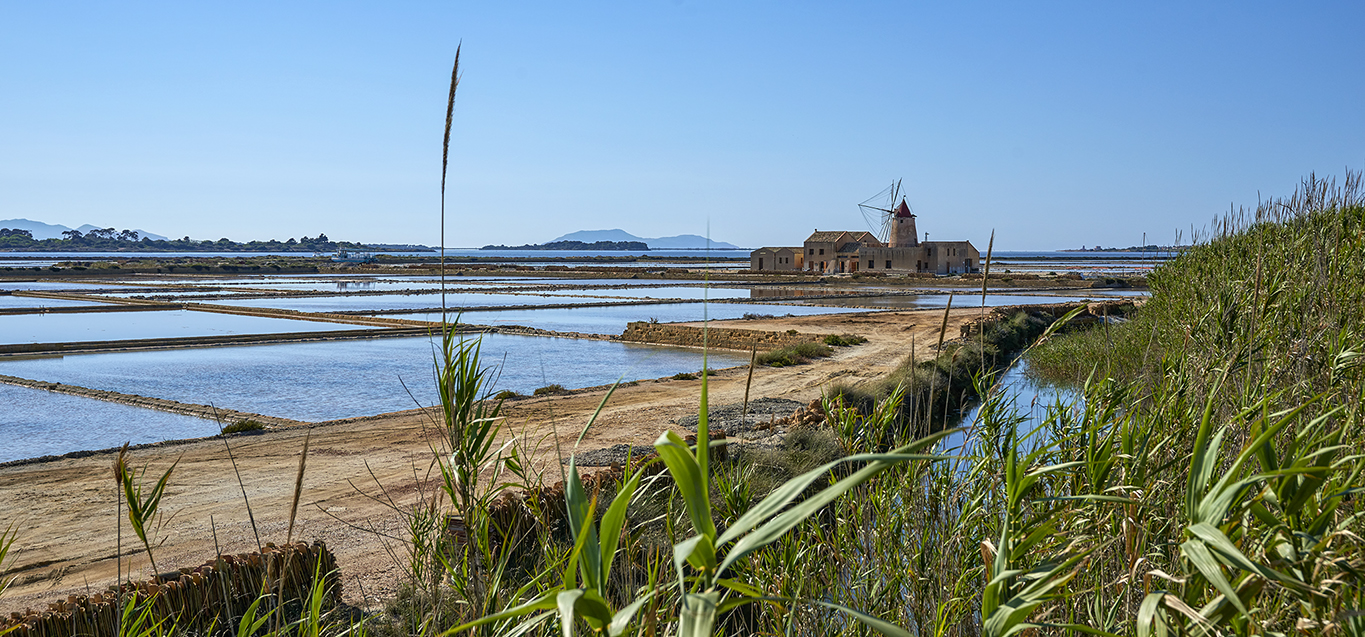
[0,385,218,462]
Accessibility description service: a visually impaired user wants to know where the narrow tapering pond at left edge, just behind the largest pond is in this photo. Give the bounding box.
[0,310,364,345]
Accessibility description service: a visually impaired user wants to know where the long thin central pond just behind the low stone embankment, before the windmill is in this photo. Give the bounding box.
[388,303,867,334]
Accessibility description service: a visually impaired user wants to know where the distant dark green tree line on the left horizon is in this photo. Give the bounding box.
[0,228,366,252]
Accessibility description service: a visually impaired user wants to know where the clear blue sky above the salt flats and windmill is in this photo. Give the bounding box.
[0,0,1365,250]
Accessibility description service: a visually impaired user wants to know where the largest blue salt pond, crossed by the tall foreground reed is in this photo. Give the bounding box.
[0,334,748,420]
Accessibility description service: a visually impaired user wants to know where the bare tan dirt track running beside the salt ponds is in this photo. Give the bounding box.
[0,308,980,612]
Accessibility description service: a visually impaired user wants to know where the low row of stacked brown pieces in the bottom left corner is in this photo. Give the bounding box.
[0,542,341,637]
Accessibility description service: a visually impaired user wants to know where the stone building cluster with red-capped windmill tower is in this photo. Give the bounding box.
[749,201,981,274]
